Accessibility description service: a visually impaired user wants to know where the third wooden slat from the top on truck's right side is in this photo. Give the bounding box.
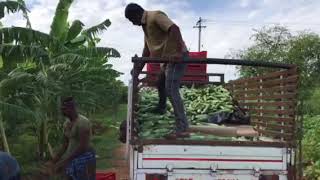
[233,84,298,95]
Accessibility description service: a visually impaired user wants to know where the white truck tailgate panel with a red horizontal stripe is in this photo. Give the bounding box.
[137,145,287,171]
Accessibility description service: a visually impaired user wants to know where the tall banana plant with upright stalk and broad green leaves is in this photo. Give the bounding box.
[0,0,120,158]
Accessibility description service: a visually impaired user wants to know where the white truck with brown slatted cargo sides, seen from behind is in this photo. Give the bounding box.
[126,54,301,180]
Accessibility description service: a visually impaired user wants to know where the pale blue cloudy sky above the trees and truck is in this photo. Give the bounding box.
[0,0,320,84]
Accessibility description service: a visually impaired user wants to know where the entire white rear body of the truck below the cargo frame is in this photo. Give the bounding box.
[130,145,288,180]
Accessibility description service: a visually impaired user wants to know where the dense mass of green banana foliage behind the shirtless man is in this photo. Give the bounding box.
[0,0,126,166]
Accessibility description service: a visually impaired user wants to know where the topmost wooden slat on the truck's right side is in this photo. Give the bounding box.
[230,68,297,85]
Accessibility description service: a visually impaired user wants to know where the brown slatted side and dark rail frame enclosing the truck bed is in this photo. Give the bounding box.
[130,56,300,177]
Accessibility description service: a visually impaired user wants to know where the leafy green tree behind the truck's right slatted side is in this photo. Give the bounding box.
[233,26,320,99]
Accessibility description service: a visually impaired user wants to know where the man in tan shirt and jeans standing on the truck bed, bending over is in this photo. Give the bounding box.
[125,3,189,139]
